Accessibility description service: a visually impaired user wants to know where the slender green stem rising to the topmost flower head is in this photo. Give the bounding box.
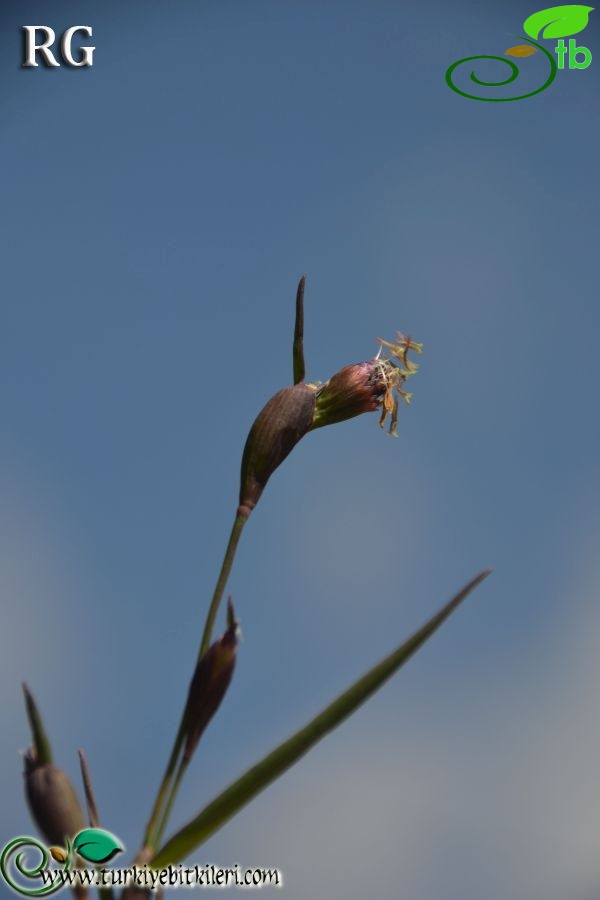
[144,513,247,849]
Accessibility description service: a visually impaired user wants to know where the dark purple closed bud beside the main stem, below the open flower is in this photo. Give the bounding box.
[183,598,238,765]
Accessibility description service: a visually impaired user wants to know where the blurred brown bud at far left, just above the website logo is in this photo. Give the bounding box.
[23,749,85,846]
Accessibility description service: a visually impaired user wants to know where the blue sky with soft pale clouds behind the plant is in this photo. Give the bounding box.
[0,0,600,900]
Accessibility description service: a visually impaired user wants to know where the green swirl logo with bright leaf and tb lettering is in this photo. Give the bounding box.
[446,5,594,103]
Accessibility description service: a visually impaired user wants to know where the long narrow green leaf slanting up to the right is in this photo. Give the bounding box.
[152,569,491,869]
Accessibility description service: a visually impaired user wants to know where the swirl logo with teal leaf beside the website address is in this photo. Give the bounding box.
[0,828,123,897]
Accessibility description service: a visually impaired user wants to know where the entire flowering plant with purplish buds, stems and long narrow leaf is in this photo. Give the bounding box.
[16,276,489,898]
